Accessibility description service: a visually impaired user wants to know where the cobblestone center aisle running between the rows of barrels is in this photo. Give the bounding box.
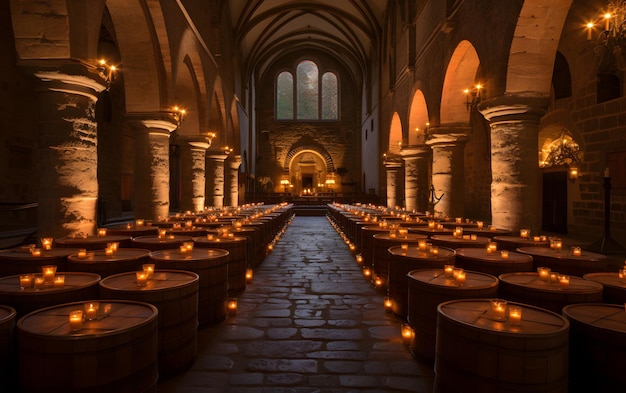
[158,216,434,393]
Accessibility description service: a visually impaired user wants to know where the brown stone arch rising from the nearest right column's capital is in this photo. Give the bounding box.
[506,0,572,96]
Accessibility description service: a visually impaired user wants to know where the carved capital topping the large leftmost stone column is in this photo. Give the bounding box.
[32,61,107,101]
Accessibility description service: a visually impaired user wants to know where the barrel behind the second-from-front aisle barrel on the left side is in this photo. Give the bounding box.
[67,248,150,278]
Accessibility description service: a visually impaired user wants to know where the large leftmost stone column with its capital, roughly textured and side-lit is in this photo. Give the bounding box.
[33,63,106,237]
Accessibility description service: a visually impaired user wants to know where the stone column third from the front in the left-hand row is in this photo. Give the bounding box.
[179,136,211,212]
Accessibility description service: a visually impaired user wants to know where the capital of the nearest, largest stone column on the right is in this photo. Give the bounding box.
[478,93,550,124]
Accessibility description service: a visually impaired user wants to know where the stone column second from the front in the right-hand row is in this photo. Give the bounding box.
[426,126,469,217]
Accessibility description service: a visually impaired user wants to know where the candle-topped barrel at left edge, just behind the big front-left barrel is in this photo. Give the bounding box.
[0,272,100,318]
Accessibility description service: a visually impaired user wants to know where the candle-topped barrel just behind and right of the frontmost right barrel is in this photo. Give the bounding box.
[498,272,603,314]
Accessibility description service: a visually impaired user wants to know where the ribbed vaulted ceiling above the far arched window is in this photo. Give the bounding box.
[228,0,388,80]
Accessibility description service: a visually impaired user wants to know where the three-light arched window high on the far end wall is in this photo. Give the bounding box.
[276,60,339,121]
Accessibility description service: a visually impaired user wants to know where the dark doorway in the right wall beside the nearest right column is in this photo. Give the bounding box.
[541,172,567,234]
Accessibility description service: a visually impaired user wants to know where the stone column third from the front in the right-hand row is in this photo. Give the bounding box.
[400,146,428,211]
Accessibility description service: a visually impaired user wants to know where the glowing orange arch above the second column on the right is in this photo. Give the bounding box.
[440,40,480,124]
